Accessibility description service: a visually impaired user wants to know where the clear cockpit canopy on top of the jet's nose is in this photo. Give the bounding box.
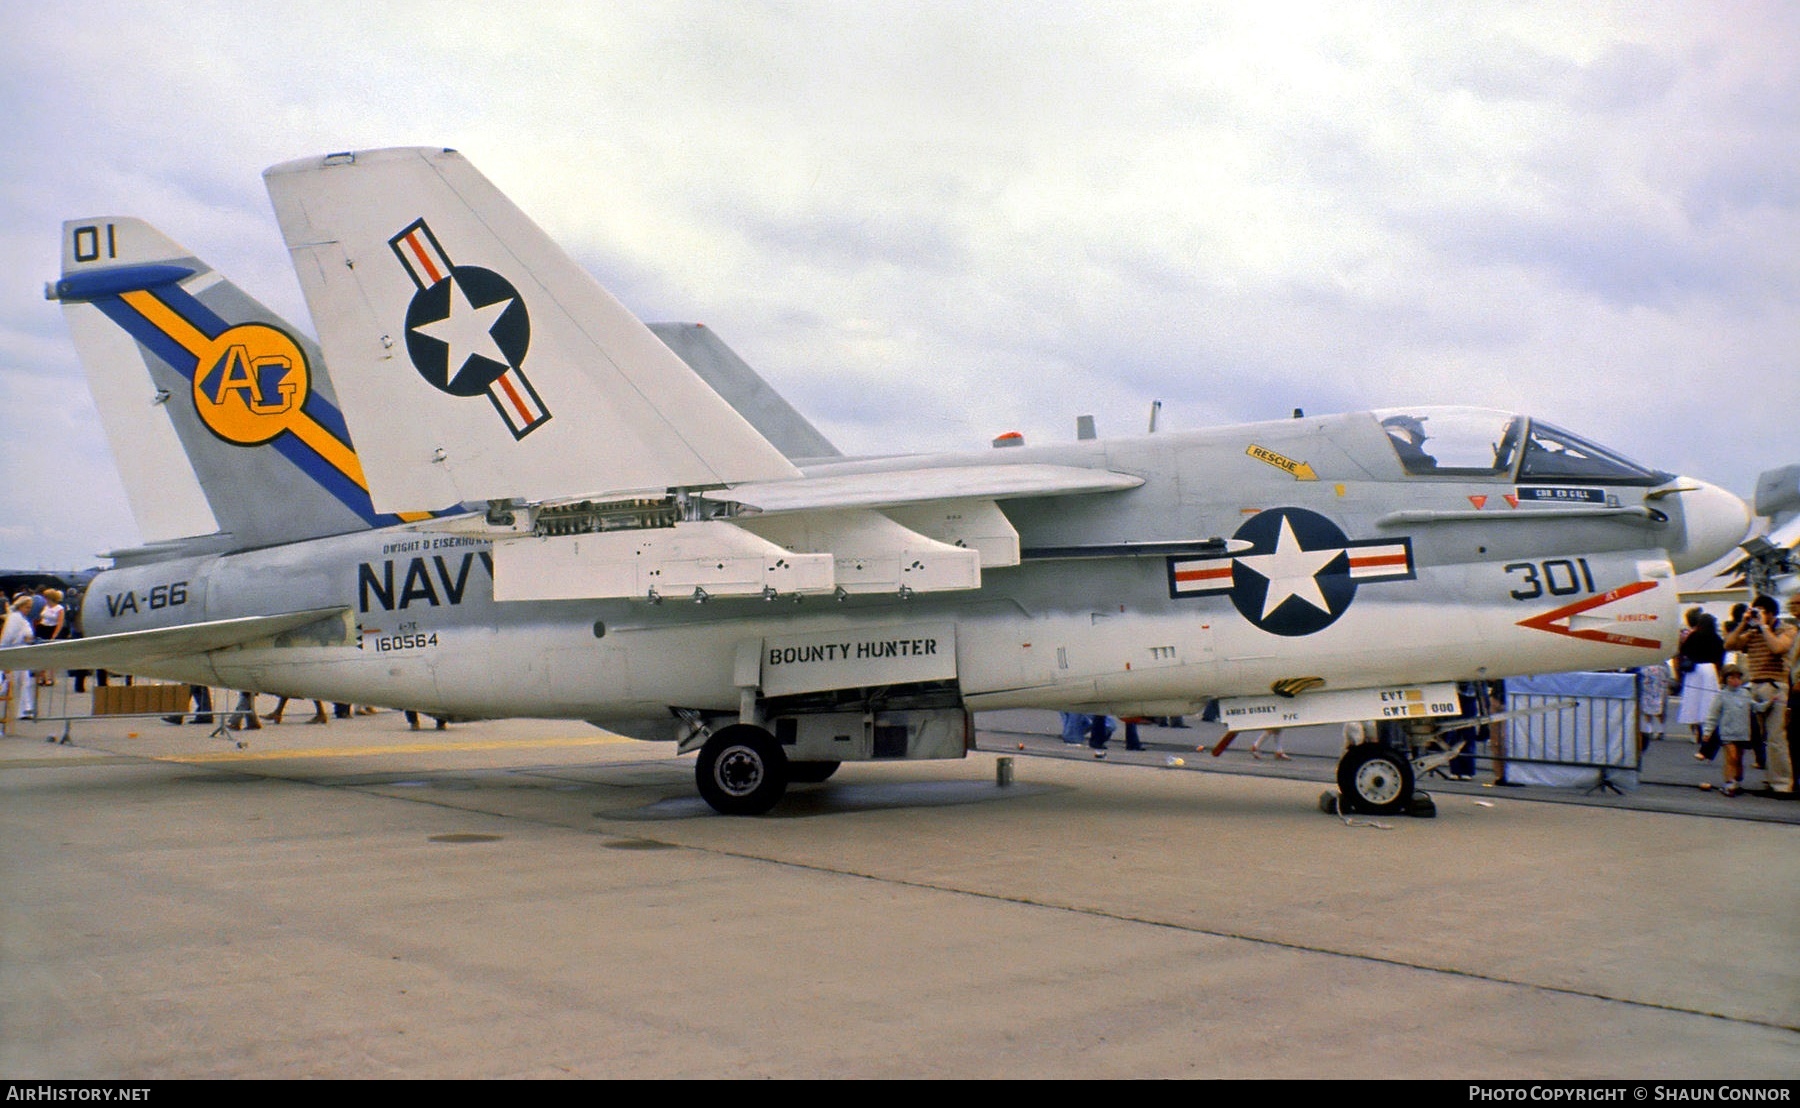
[1375,407,1672,486]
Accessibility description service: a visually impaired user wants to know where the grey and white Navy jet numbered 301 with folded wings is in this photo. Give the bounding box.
[14,149,1748,813]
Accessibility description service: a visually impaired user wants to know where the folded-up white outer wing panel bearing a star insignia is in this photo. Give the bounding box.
[263,147,797,511]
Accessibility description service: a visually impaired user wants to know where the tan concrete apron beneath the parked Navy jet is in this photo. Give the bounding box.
[0,703,1800,1077]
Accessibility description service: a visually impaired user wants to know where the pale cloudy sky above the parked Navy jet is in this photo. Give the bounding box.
[0,0,1800,567]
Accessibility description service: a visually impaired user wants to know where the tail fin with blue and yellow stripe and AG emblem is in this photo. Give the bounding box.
[45,216,442,549]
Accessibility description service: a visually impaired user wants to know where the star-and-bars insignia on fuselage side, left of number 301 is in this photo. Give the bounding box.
[1168,507,1415,637]
